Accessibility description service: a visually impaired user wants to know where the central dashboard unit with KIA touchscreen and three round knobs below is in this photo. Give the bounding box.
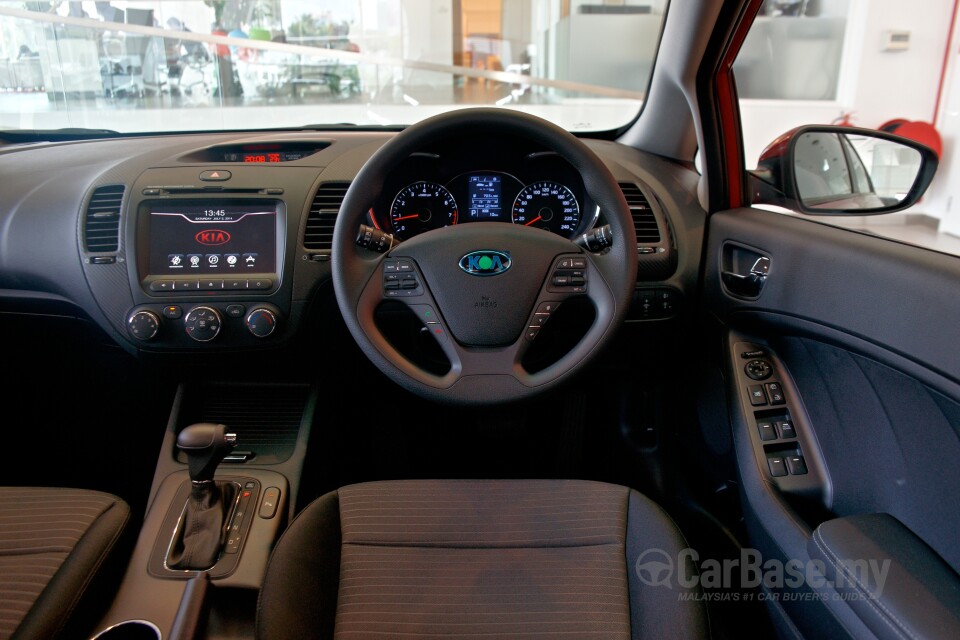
[125,170,289,349]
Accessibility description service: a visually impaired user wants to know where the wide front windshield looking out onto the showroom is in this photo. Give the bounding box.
[0,0,666,132]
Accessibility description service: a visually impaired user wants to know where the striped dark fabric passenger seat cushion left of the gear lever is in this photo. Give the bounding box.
[0,487,130,639]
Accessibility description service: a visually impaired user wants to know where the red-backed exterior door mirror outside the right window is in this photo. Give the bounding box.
[749,125,938,215]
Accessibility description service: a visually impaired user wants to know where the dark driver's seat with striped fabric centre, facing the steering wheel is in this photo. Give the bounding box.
[257,480,709,640]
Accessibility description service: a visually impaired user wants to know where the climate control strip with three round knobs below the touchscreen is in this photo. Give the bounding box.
[127,302,282,347]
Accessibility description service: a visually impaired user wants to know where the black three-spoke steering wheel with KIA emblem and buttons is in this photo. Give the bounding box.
[331,108,637,405]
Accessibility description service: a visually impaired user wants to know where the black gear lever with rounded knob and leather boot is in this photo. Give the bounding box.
[167,422,237,570]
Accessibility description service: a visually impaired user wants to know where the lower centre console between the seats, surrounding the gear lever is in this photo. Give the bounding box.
[94,383,319,640]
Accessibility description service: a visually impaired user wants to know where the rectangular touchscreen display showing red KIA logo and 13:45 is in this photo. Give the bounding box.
[148,200,277,277]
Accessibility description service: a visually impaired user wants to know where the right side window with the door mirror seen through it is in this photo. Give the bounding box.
[733,0,960,255]
